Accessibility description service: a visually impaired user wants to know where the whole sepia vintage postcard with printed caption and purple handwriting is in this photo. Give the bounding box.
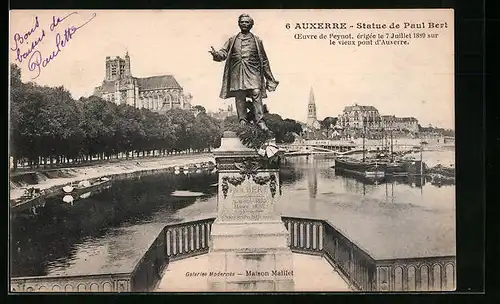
[9,9,457,294]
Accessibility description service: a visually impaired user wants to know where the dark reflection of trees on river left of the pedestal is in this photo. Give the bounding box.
[11,173,217,276]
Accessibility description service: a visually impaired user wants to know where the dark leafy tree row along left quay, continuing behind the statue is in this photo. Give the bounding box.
[9,64,301,170]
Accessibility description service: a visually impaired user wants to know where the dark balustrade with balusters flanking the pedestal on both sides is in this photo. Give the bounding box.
[11,217,456,292]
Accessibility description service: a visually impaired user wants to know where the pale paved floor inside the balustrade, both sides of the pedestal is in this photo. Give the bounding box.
[156,253,352,292]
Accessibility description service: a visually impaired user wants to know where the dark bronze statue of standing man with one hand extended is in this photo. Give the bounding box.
[209,14,279,131]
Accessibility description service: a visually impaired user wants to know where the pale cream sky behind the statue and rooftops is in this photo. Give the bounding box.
[9,10,455,128]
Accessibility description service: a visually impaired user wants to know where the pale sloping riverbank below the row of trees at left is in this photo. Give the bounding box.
[10,153,214,200]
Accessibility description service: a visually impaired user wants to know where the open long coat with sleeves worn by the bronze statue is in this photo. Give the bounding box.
[214,34,279,99]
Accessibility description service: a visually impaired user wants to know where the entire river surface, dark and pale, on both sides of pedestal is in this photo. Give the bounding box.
[10,151,455,277]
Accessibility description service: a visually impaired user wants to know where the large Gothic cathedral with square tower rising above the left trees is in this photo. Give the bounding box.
[94,52,192,113]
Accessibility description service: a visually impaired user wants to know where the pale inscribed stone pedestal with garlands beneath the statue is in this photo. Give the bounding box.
[208,132,294,291]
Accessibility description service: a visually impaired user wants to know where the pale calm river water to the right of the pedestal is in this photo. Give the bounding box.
[281,152,456,258]
